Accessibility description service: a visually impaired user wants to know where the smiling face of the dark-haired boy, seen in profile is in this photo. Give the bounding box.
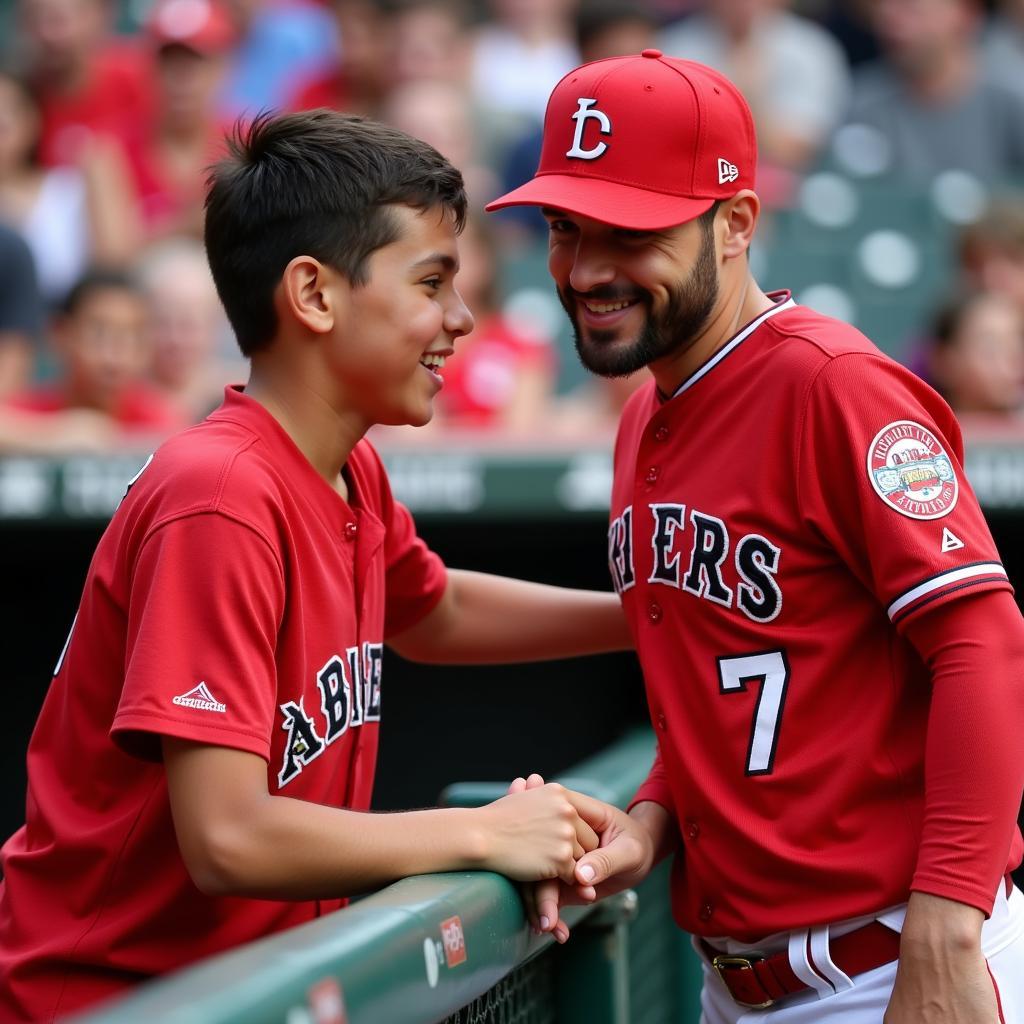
[331,206,473,427]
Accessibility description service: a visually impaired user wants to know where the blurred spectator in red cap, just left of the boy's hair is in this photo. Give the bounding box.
[128,0,236,238]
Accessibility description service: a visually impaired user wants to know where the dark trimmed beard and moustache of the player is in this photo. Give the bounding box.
[557,220,718,377]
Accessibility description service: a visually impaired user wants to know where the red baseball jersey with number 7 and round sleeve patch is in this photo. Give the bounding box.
[608,293,1021,941]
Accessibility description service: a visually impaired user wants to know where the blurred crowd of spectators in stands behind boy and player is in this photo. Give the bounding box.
[0,0,1024,453]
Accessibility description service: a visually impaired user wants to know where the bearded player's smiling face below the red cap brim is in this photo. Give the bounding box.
[543,208,719,377]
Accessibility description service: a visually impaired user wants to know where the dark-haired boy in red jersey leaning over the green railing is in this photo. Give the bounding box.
[0,112,629,1024]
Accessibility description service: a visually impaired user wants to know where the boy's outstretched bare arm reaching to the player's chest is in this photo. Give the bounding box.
[389,569,633,665]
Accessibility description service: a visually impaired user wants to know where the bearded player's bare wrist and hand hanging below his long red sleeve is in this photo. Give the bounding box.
[883,893,999,1024]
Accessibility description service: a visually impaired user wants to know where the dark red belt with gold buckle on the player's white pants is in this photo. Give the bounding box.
[700,921,900,1010]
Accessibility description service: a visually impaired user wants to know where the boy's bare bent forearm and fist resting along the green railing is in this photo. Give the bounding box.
[163,736,597,899]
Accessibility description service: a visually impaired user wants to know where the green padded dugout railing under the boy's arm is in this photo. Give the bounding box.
[70,730,700,1024]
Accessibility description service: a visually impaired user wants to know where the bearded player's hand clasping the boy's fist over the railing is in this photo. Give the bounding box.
[512,775,665,942]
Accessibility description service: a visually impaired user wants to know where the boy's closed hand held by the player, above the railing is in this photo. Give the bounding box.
[476,782,598,883]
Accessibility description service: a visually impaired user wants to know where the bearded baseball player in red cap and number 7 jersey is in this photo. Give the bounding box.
[489,49,1024,1024]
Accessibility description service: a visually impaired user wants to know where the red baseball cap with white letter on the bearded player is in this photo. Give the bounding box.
[486,49,758,230]
